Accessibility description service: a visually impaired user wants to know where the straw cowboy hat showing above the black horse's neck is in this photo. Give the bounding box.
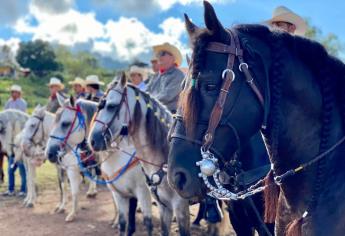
[265,6,307,35]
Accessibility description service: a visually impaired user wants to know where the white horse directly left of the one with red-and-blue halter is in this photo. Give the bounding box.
[20,106,94,222]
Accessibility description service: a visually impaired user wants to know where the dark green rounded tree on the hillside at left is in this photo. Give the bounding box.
[16,40,62,77]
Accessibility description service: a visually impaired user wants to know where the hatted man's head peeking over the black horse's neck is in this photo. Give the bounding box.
[265,6,308,36]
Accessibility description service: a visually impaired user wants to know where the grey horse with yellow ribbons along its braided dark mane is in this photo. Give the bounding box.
[89,74,190,235]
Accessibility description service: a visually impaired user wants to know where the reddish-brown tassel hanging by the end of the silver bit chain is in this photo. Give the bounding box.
[264,170,280,224]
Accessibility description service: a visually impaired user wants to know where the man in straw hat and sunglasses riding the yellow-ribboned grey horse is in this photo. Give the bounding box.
[147,43,184,113]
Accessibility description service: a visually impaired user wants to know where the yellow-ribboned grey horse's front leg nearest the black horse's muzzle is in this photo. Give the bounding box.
[174,200,190,236]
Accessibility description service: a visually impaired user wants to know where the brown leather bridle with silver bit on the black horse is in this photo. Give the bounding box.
[191,30,268,200]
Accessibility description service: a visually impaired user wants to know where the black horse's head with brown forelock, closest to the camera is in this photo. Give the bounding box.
[168,2,271,198]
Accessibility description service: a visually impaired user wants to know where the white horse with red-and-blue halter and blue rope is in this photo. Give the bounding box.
[46,97,153,235]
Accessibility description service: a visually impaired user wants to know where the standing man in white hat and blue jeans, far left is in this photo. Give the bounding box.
[3,85,27,197]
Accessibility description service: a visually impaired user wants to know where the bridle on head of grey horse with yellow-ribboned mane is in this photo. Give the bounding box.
[91,87,131,143]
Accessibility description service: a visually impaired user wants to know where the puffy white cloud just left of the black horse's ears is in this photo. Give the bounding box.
[93,17,187,61]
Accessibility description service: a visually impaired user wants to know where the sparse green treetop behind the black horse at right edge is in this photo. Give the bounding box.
[305,19,344,57]
